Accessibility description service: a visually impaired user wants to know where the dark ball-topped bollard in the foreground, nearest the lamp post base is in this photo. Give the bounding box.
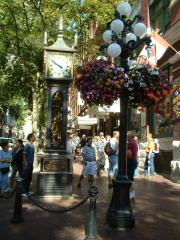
[84,186,98,240]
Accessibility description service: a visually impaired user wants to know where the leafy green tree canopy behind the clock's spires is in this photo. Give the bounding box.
[0,0,136,128]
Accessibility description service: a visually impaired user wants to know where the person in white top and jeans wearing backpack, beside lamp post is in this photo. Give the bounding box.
[108,131,119,188]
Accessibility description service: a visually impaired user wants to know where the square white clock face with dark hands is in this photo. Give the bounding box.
[46,53,72,78]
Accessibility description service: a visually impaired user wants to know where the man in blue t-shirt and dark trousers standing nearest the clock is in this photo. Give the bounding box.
[22,133,36,197]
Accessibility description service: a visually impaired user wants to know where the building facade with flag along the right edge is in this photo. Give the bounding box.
[134,0,180,181]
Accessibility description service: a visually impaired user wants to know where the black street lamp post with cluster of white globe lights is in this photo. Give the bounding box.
[101,2,151,230]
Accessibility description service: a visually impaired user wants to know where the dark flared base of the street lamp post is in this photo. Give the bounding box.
[106,178,135,231]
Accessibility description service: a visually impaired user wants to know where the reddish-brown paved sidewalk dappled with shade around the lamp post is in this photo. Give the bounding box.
[0,162,180,240]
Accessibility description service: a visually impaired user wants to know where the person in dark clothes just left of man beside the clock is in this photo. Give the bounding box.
[10,139,24,188]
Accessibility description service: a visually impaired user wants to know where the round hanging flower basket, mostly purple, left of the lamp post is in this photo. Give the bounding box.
[75,59,127,105]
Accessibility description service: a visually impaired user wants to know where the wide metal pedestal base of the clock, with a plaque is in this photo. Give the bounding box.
[36,151,73,196]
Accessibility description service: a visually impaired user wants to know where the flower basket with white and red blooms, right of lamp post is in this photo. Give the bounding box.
[128,64,172,107]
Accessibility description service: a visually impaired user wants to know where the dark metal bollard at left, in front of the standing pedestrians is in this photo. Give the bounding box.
[11,178,24,224]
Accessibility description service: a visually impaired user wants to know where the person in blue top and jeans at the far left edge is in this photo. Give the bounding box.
[0,142,12,196]
